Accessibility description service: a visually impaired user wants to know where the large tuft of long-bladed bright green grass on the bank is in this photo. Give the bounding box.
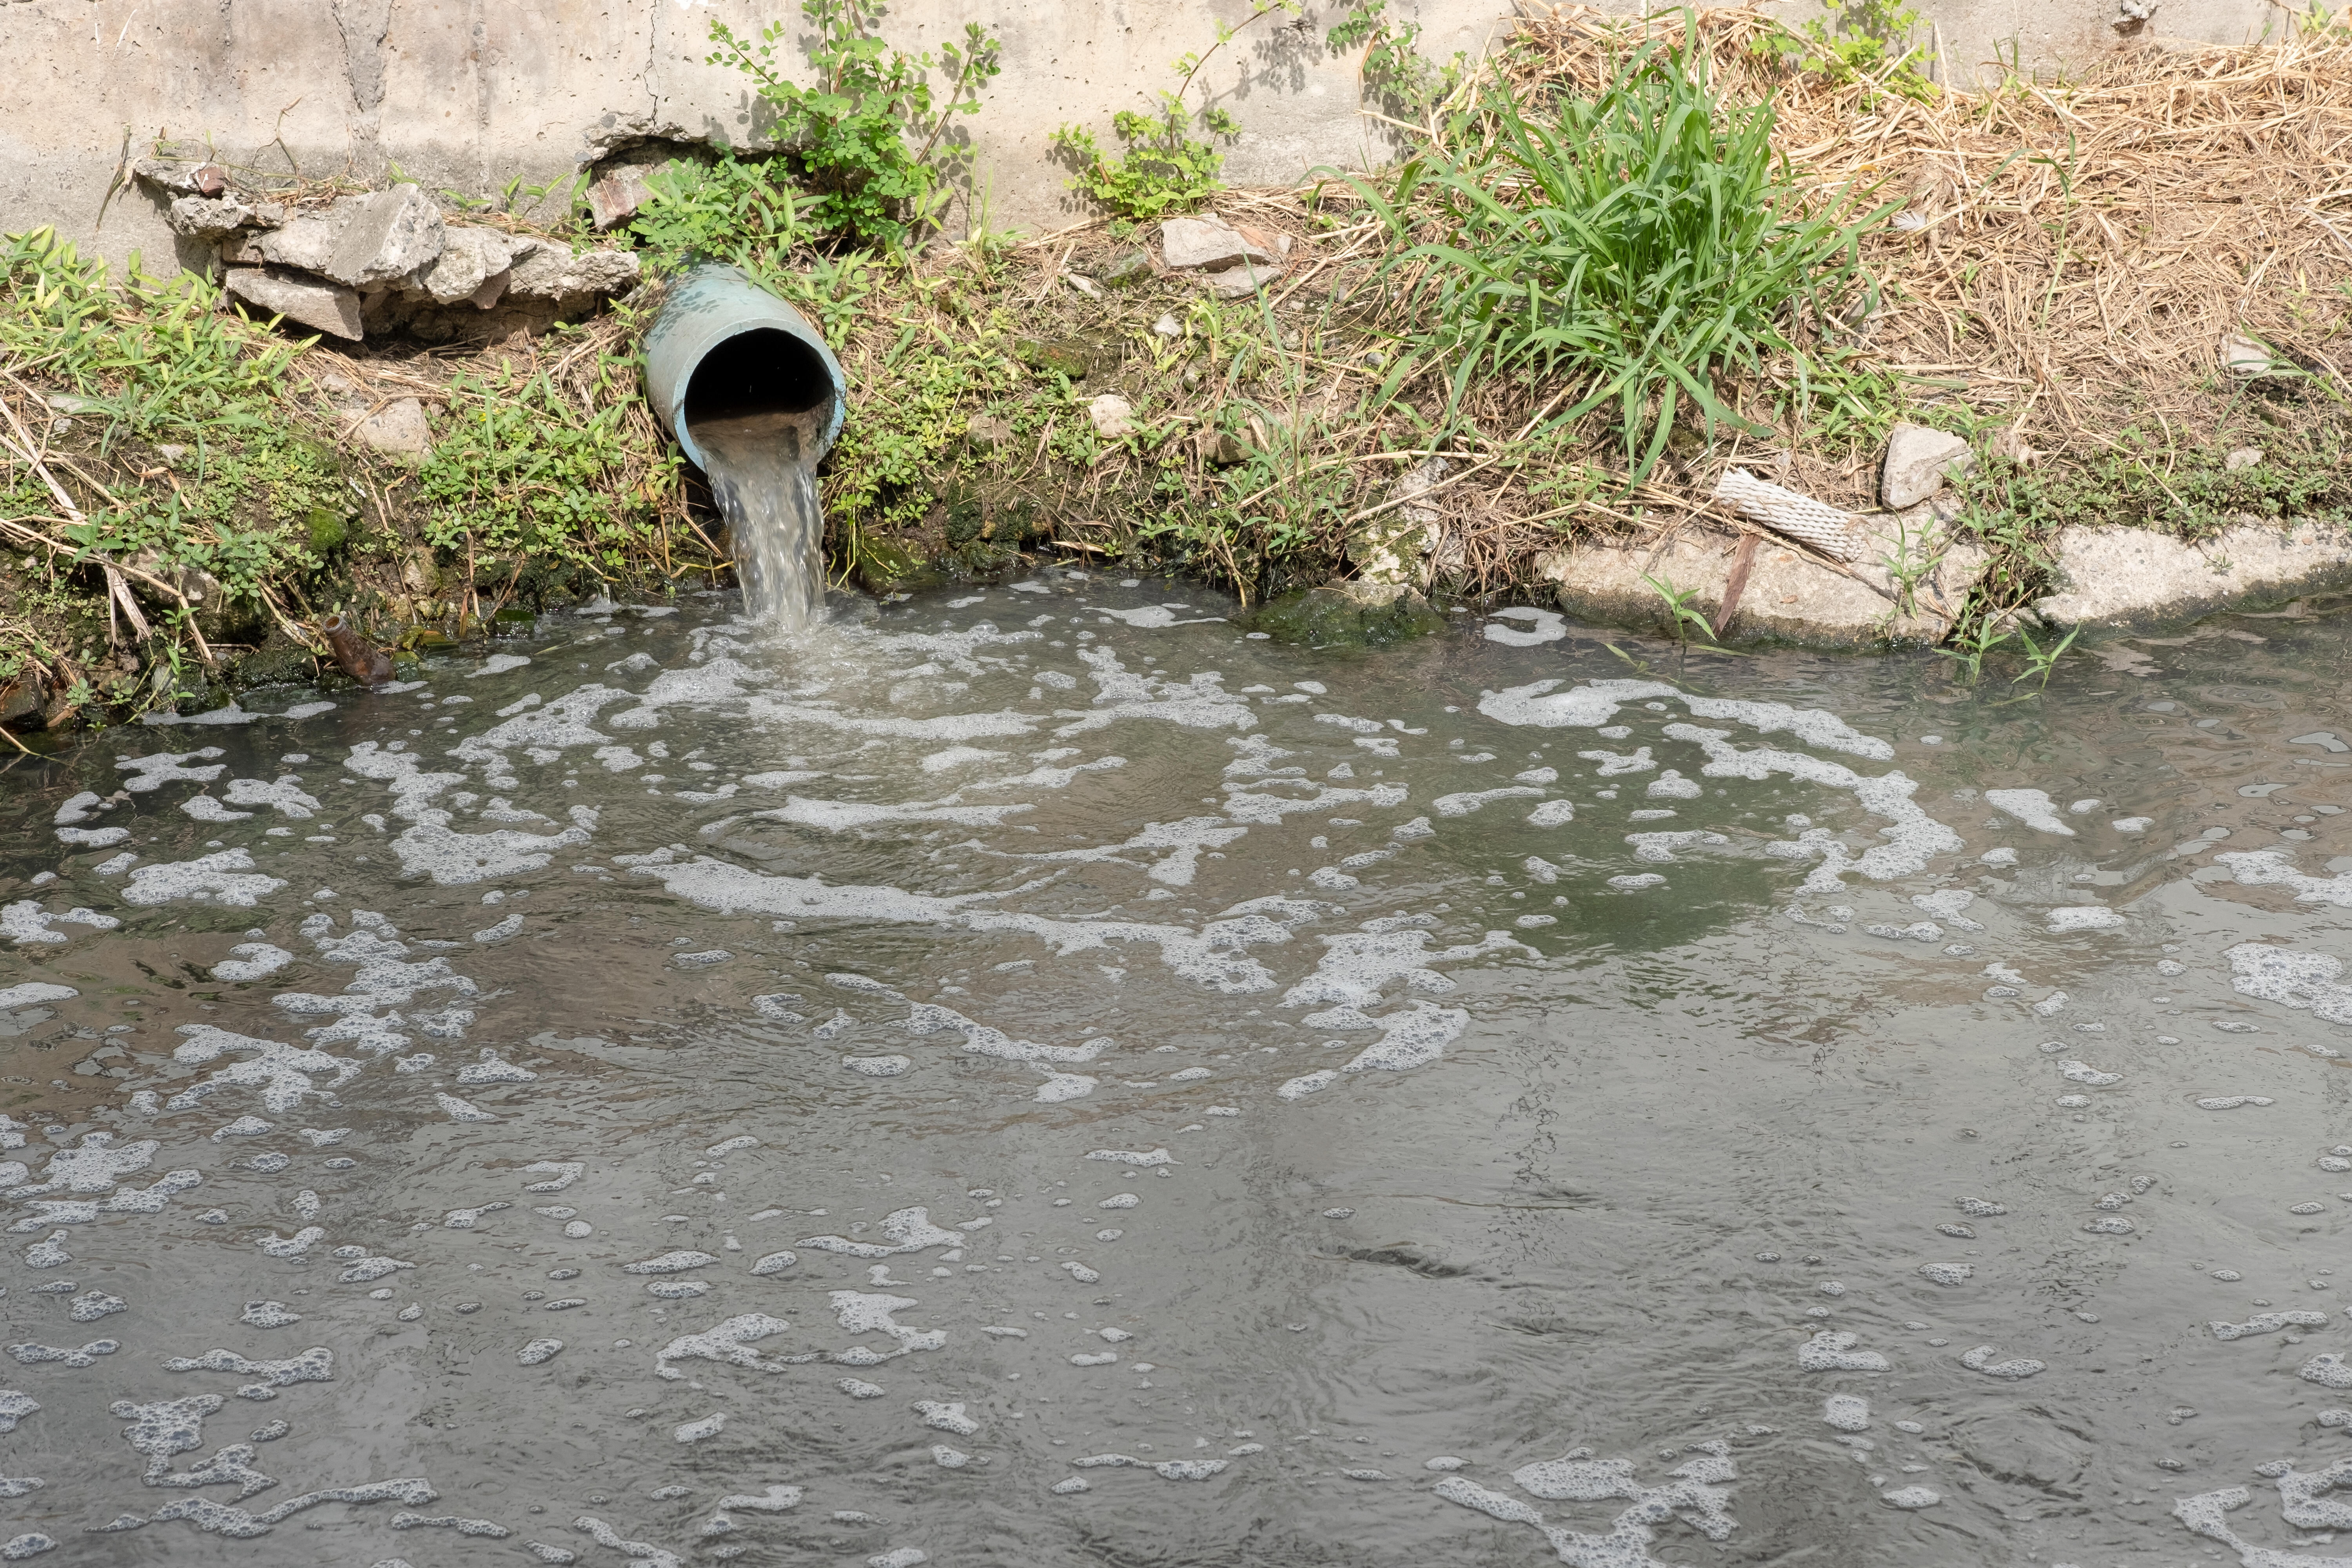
[1355,26,1891,482]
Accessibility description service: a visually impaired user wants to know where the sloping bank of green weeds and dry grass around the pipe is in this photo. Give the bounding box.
[0,7,2352,726]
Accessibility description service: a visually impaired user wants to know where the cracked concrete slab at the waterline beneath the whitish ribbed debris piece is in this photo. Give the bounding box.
[1536,508,1985,649]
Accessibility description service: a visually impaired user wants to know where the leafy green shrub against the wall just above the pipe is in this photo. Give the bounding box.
[708,0,1002,249]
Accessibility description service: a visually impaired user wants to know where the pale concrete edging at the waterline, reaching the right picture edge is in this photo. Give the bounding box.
[2034,522,2352,628]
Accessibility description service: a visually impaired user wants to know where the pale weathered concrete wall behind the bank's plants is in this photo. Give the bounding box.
[0,0,2286,270]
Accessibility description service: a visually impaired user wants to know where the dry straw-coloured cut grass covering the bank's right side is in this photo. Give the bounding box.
[1515,7,2352,482]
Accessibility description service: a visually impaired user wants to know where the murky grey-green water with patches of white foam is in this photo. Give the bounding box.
[0,578,2352,1568]
